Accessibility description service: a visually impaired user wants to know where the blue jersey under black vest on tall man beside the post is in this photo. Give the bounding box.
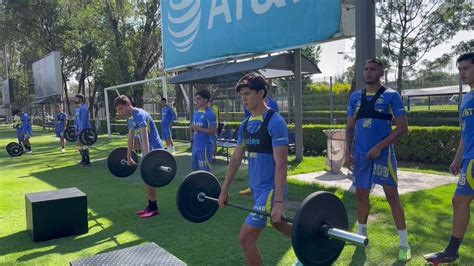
[347,88,407,155]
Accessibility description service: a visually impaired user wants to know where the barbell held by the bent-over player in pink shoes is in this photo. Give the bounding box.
[107,147,177,187]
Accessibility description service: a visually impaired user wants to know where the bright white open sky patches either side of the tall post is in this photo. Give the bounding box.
[313,30,474,81]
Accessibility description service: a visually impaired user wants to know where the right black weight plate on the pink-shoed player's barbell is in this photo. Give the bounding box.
[140,149,177,187]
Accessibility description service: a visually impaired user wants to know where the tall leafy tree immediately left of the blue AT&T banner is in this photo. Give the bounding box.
[103,0,162,106]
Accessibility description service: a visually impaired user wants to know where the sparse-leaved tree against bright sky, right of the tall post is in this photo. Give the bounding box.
[378,0,474,91]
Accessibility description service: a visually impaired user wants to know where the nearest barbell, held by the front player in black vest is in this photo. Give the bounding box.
[176,171,369,265]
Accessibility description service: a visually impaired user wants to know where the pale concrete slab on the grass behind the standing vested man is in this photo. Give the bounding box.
[288,168,458,196]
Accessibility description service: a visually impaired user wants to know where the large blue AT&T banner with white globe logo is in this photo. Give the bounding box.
[161,0,341,71]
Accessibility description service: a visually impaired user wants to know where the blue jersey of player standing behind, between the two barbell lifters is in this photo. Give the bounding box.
[192,107,217,151]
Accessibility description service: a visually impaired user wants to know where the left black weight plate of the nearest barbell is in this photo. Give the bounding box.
[176,171,221,223]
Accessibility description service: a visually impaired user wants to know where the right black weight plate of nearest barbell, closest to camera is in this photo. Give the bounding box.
[292,192,349,265]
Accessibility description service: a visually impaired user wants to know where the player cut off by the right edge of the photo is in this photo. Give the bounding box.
[424,53,474,265]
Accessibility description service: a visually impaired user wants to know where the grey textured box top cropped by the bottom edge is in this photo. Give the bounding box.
[71,243,186,266]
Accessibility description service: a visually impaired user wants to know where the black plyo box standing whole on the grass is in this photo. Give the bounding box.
[25,188,88,242]
